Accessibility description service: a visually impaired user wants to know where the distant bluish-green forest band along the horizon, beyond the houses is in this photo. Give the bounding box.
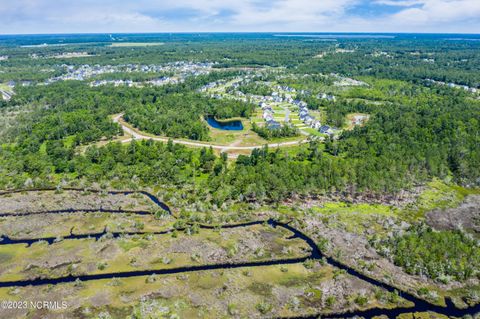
[0,34,480,87]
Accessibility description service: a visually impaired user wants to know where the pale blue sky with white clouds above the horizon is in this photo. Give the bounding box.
[0,0,480,34]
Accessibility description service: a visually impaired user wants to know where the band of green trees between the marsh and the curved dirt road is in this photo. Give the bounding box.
[0,86,480,200]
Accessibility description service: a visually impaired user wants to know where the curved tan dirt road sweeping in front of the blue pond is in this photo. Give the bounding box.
[113,114,307,152]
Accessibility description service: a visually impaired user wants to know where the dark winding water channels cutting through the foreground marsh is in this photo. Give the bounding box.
[0,188,480,319]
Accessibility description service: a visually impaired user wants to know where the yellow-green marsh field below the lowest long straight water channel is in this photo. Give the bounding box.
[0,264,404,318]
